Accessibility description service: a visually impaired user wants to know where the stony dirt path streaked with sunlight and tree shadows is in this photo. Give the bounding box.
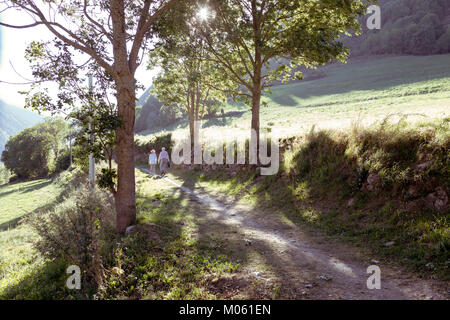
[136,169,443,299]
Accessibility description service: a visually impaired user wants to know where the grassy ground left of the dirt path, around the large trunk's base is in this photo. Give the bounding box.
[0,170,272,300]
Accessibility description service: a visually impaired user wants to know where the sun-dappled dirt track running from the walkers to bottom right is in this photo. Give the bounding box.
[140,168,450,300]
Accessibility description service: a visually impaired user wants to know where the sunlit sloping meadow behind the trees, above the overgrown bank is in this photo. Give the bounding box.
[136,55,450,140]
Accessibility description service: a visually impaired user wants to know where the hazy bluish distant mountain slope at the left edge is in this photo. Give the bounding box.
[0,100,43,154]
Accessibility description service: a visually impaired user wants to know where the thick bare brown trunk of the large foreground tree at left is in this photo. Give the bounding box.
[115,76,136,233]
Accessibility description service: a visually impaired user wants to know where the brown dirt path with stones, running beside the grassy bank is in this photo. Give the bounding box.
[141,169,449,300]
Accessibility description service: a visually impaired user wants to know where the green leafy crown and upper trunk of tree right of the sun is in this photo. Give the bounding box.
[190,0,367,155]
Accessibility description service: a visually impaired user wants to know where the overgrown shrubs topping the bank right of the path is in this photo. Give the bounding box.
[284,119,450,197]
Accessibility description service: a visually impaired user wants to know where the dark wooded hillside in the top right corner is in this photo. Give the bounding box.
[345,0,450,56]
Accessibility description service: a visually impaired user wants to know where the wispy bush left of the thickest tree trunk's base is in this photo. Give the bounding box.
[29,184,115,297]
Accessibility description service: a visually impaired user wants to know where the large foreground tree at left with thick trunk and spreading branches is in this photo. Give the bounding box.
[0,0,181,233]
